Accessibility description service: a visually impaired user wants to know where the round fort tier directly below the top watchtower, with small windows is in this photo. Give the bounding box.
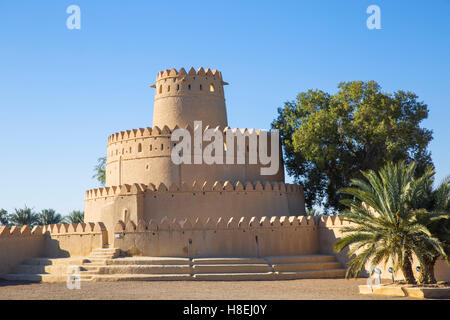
[106,126,284,186]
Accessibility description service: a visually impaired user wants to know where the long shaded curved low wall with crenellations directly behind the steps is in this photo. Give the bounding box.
[114,216,318,257]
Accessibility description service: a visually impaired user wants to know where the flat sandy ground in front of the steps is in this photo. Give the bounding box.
[0,279,416,300]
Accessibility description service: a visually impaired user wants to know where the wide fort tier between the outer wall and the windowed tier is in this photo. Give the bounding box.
[85,181,305,244]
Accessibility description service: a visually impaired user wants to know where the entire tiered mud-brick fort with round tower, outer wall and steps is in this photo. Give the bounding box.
[0,68,449,281]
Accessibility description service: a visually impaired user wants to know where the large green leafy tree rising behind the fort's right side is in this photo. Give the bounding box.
[272,81,432,211]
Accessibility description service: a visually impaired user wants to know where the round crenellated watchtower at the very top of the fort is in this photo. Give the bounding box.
[152,68,228,128]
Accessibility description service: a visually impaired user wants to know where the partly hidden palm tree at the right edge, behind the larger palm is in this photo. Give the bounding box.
[415,175,450,283]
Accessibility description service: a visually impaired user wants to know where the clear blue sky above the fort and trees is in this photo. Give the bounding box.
[0,0,450,215]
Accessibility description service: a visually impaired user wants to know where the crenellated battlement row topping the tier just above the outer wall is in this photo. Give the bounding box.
[86,181,302,200]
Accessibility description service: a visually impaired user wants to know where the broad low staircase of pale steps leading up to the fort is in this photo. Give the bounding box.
[3,248,345,282]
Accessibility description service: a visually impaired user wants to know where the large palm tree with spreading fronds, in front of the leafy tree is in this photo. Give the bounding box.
[334,161,443,283]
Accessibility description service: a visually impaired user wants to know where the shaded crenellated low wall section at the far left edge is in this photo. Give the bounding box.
[0,226,45,274]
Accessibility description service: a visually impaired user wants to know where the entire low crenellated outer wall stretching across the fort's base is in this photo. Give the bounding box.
[0,216,450,281]
